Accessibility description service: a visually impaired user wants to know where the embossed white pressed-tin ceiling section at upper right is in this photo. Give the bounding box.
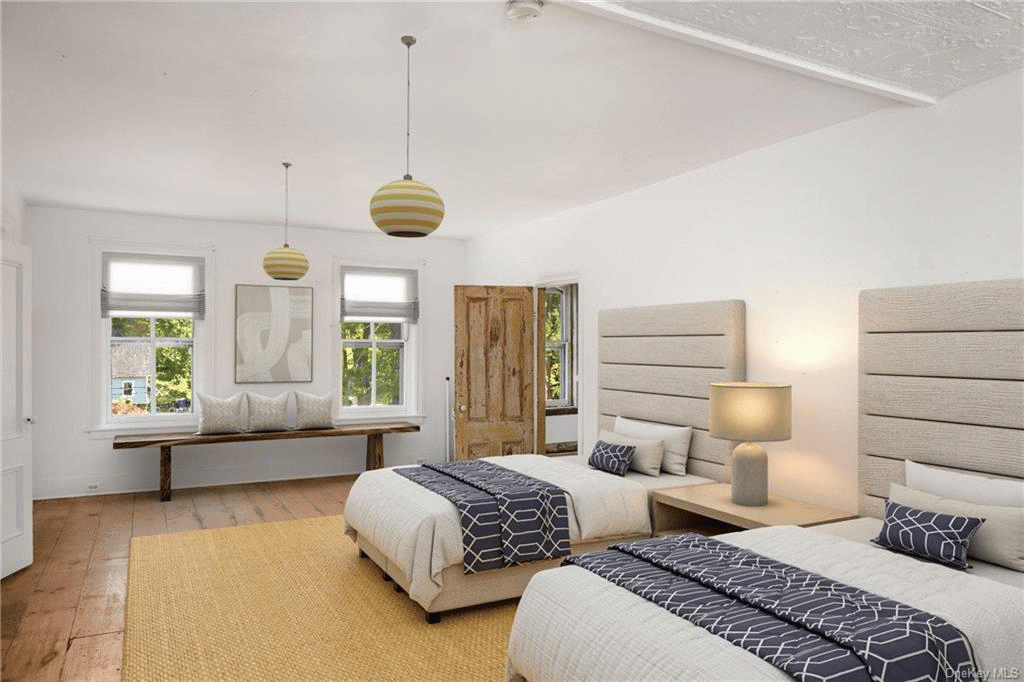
[595,0,1024,102]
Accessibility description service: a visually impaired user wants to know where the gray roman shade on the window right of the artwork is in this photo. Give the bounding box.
[341,265,420,323]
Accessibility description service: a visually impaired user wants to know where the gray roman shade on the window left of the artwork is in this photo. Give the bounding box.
[99,252,206,319]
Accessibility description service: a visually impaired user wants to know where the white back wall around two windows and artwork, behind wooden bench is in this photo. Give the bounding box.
[26,206,465,498]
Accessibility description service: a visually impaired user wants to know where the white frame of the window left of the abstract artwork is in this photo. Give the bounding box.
[87,239,216,432]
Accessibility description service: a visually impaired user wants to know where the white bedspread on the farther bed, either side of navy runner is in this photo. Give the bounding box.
[344,455,650,605]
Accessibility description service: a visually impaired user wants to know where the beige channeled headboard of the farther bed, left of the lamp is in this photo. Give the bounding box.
[597,301,746,480]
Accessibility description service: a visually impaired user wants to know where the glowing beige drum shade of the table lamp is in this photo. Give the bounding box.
[709,381,793,441]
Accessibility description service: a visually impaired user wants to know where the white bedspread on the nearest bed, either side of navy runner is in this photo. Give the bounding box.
[507,526,1024,682]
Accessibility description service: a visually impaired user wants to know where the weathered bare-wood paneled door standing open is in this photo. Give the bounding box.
[455,286,537,460]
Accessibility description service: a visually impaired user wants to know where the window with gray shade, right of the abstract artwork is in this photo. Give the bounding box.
[339,266,419,416]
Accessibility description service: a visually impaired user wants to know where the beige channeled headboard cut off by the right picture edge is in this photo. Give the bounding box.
[859,280,1024,517]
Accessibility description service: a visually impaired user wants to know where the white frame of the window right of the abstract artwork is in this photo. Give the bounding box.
[333,258,423,424]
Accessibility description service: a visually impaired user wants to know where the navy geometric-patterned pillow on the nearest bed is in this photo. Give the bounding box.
[873,500,985,570]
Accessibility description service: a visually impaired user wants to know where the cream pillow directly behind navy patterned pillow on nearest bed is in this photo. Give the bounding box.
[889,483,1024,571]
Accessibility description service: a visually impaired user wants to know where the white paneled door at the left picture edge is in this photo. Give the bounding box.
[0,242,32,577]
